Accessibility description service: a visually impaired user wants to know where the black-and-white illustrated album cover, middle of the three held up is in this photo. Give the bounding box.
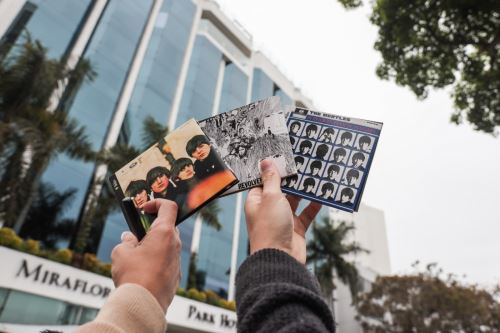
[199,96,297,195]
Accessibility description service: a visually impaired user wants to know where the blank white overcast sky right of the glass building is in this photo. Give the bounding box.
[217,0,500,284]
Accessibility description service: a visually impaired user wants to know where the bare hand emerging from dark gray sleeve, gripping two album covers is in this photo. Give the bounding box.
[245,160,321,264]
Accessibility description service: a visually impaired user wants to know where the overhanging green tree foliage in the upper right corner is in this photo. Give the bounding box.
[371,0,500,133]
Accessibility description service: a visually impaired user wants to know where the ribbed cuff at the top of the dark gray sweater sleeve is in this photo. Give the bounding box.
[236,249,319,293]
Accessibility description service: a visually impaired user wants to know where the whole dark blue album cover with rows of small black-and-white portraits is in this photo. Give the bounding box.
[282,108,382,212]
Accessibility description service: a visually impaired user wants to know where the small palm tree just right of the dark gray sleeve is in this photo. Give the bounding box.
[307,217,367,310]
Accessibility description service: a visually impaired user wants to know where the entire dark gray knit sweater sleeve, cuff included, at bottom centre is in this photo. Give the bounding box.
[236,249,335,333]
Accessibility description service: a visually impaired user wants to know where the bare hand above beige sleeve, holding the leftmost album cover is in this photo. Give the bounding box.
[111,199,181,311]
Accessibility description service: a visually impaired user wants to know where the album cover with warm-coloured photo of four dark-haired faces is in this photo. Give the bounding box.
[109,119,238,230]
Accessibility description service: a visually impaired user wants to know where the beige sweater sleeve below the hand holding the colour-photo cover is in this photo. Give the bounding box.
[75,284,167,333]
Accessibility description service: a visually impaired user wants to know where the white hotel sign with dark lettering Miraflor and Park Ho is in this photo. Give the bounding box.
[0,246,236,333]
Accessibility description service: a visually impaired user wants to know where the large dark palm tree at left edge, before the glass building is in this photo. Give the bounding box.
[0,35,95,231]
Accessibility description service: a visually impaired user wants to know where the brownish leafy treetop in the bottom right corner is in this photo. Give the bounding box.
[357,265,500,333]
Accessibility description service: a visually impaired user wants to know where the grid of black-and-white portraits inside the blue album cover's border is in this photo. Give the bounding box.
[283,117,376,206]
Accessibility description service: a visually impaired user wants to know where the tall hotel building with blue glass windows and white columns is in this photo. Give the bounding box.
[0,0,389,332]
